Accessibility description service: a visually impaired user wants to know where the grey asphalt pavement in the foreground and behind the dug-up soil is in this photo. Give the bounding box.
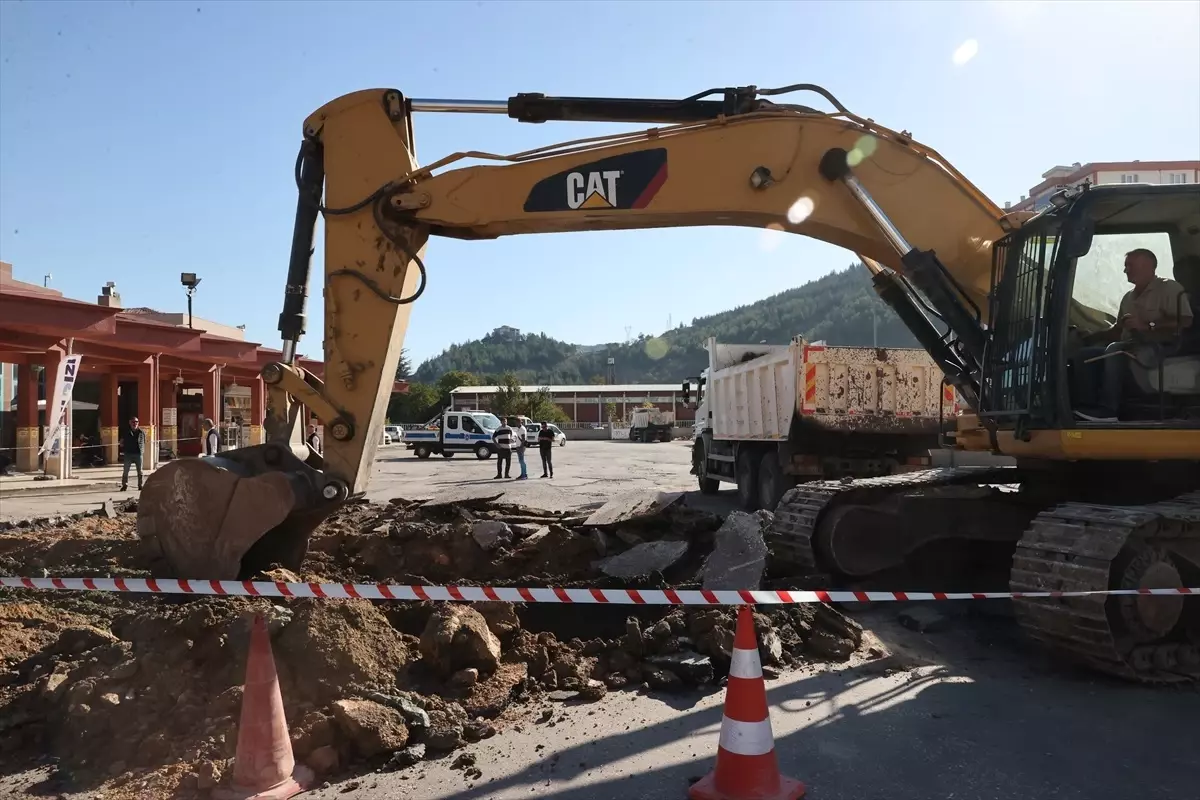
[0,441,1200,800]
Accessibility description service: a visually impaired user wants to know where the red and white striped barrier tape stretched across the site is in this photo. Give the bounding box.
[0,577,1200,606]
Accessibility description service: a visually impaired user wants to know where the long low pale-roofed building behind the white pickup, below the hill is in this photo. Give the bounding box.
[450,380,695,426]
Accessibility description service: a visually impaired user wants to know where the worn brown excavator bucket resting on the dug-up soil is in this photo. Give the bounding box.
[138,445,340,581]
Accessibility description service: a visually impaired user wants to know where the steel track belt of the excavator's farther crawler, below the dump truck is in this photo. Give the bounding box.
[768,467,1016,572]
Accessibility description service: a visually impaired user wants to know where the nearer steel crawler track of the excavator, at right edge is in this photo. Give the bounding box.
[1010,492,1200,684]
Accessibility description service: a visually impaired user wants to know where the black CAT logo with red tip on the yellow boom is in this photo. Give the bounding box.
[524,148,667,213]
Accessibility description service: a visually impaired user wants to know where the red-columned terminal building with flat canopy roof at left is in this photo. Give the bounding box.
[0,261,406,477]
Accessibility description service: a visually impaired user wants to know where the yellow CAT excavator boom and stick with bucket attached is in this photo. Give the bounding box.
[139,85,1019,578]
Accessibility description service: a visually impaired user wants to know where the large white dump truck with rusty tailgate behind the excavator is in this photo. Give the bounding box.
[683,336,958,511]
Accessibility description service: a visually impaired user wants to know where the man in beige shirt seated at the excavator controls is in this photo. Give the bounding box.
[1075,247,1193,422]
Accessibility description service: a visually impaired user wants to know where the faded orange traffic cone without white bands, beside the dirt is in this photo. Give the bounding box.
[212,616,313,800]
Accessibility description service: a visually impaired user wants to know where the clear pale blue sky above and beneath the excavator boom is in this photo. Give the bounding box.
[0,0,1200,361]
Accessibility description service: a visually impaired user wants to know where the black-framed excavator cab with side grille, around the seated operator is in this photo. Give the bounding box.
[979,185,1200,438]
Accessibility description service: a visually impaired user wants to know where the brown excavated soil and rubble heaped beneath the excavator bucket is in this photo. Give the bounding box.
[0,500,862,800]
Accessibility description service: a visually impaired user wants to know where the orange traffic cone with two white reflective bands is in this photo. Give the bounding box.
[688,606,805,800]
